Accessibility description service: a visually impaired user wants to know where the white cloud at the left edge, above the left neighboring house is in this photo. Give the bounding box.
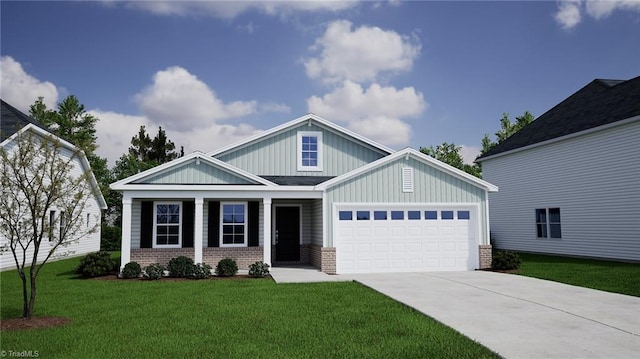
[0,56,58,113]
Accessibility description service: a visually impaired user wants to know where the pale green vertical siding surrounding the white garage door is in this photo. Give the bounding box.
[324,158,487,246]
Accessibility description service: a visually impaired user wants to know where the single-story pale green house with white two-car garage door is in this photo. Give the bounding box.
[111,114,497,273]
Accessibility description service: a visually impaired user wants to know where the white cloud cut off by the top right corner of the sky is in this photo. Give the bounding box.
[554,0,640,29]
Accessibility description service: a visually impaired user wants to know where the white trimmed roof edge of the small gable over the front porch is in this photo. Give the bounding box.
[110,151,276,190]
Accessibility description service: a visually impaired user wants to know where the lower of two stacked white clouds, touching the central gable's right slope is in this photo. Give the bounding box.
[307,81,427,145]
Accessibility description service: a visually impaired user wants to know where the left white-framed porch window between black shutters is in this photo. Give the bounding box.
[153,202,182,248]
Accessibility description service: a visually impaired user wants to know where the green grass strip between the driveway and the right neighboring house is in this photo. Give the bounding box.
[518,253,640,297]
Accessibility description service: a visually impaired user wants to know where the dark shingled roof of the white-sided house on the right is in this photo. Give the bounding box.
[477,76,640,161]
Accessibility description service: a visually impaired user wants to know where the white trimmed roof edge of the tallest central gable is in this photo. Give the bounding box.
[208,113,395,157]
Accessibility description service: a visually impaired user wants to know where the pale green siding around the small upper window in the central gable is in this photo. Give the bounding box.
[216,124,385,176]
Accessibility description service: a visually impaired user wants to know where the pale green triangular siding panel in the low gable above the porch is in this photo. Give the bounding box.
[135,159,254,184]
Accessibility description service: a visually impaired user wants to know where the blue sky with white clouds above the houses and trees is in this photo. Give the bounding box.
[0,0,640,164]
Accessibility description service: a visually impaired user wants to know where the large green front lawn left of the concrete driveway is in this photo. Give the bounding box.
[0,259,498,358]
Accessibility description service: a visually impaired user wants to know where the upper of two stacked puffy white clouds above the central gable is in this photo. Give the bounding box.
[303,20,421,83]
